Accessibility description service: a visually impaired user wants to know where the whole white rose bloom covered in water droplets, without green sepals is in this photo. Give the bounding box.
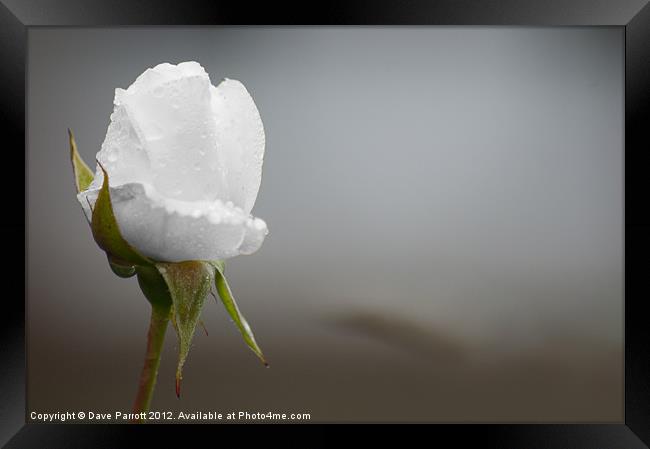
[78,62,268,262]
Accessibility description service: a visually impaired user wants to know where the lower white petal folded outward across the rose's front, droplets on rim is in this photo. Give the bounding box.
[78,183,268,262]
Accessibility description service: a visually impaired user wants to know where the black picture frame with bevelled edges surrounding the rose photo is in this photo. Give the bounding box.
[6,0,650,449]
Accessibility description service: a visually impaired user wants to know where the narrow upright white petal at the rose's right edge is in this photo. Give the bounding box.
[210,78,265,213]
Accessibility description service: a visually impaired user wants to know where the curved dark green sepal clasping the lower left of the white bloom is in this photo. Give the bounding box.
[90,165,153,266]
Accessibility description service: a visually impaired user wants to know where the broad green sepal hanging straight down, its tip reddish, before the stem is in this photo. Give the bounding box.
[156,261,212,397]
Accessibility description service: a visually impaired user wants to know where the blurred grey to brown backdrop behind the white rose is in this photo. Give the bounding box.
[27,27,624,422]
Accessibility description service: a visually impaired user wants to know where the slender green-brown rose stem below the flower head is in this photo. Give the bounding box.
[133,305,171,422]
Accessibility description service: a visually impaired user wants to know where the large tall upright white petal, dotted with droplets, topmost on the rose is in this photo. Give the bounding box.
[104,63,229,201]
